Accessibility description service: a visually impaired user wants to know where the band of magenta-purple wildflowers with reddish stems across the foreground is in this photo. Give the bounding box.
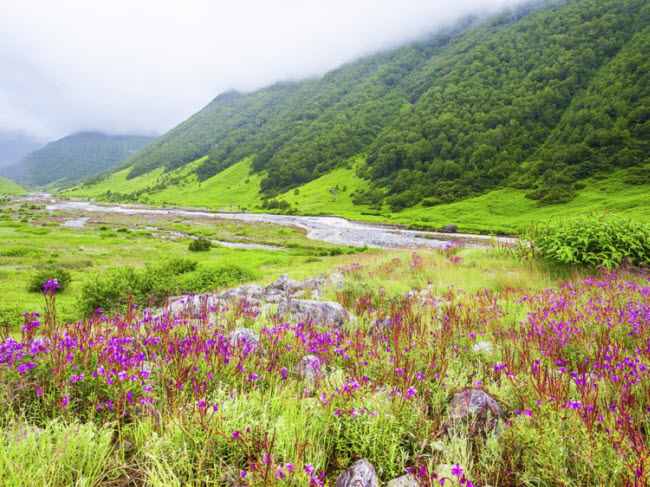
[0,264,650,486]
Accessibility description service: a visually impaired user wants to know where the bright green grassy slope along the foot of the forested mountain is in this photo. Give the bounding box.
[62,160,650,233]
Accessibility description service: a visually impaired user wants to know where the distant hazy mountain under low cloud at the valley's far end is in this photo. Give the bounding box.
[0,132,155,187]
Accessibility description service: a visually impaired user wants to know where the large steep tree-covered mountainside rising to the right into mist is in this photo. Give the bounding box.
[67,0,650,231]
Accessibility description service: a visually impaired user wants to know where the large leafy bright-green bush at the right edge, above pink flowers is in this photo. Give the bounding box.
[528,215,650,268]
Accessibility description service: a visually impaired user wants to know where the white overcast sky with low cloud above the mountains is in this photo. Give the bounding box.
[0,0,524,140]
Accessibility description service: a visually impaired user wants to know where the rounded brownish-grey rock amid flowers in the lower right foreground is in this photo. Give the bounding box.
[444,389,506,437]
